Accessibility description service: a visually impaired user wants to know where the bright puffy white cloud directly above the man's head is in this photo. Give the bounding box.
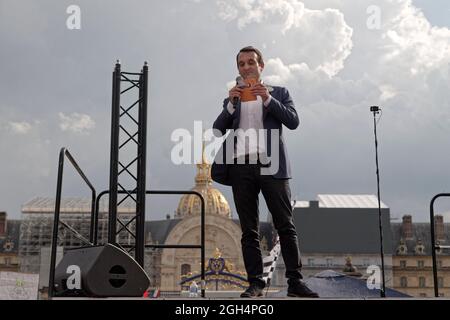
[217,0,353,76]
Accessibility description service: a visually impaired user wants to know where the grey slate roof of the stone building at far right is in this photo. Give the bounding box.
[391,222,450,256]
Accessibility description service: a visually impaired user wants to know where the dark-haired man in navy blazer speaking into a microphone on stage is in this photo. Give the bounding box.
[211,47,318,298]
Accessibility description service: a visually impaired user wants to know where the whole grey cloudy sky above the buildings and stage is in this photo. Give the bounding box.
[0,0,450,221]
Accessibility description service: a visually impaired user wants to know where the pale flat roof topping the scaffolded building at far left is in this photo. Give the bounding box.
[22,196,136,213]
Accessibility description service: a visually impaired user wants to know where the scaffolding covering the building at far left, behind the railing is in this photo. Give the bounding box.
[19,197,135,273]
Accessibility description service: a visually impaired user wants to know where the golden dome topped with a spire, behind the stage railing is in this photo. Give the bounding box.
[175,141,231,219]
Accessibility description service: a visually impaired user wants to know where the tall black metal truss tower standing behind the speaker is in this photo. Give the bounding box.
[108,60,148,267]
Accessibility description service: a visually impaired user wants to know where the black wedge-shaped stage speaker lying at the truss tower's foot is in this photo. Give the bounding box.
[55,243,150,297]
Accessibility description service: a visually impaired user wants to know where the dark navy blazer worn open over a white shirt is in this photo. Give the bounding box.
[211,86,299,185]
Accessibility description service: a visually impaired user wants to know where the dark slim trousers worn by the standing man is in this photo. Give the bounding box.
[230,163,302,283]
